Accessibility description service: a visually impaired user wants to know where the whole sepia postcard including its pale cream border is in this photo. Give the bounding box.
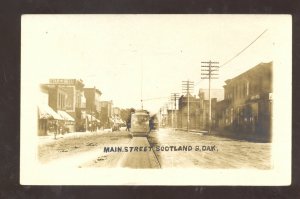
[20,14,292,186]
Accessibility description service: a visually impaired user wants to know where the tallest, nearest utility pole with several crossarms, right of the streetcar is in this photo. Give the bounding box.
[201,61,219,133]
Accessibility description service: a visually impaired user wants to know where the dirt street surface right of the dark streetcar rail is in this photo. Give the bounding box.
[149,129,271,169]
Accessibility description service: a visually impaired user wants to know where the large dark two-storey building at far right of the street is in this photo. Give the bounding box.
[217,62,273,139]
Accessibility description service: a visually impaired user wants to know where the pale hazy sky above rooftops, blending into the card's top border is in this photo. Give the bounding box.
[21,15,291,111]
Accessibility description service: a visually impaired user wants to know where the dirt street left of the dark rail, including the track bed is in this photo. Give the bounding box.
[38,131,160,168]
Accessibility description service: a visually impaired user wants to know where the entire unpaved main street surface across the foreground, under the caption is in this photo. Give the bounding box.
[38,129,271,169]
